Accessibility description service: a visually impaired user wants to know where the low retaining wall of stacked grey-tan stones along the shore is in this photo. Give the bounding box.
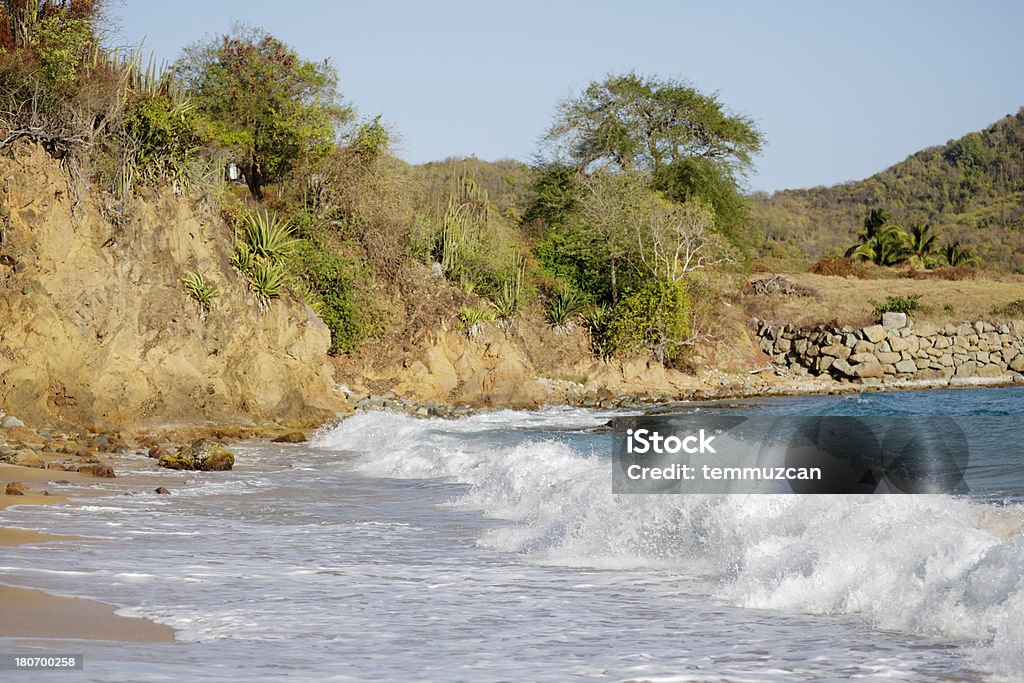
[753,313,1024,384]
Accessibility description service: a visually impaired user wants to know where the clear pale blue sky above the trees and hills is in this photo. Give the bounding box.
[111,0,1024,190]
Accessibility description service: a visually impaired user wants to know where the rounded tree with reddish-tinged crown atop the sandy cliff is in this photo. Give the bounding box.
[177,27,351,199]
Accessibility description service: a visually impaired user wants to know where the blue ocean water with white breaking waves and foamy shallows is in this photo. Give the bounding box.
[0,388,1024,681]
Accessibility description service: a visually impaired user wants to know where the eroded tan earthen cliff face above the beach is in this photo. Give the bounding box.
[0,143,345,428]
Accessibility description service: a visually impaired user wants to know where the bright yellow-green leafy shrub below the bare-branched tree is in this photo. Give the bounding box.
[606,280,690,365]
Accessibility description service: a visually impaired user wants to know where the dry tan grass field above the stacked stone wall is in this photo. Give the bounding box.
[743,271,1024,325]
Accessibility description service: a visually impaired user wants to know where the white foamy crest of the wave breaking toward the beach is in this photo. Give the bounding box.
[312,410,1024,679]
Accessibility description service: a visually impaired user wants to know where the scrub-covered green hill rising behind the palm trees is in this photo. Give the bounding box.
[753,109,1024,272]
